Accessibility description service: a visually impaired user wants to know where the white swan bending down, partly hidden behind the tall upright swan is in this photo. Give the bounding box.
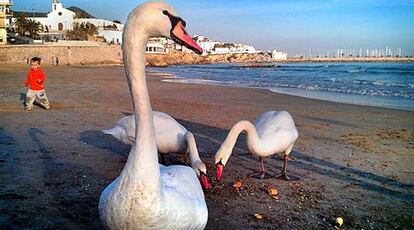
[102,111,211,189]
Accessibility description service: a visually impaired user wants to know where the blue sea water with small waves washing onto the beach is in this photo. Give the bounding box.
[151,63,414,111]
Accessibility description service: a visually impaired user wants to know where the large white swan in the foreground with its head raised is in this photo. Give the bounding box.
[99,2,208,229]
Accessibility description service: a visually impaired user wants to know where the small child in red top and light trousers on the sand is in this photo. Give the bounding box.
[24,57,50,111]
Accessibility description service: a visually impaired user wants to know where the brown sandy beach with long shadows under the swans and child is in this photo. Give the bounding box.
[0,65,414,229]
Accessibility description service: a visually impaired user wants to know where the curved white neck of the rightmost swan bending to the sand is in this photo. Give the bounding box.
[221,120,260,162]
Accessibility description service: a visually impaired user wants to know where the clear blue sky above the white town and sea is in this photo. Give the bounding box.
[12,0,414,55]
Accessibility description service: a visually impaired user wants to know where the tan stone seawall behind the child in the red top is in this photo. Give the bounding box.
[0,45,122,65]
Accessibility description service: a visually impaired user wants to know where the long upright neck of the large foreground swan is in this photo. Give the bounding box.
[119,19,161,195]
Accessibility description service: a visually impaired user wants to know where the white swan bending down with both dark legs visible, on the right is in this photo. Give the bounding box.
[215,111,298,181]
